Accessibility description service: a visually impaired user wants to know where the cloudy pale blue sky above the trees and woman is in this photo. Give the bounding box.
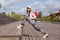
[0,0,60,16]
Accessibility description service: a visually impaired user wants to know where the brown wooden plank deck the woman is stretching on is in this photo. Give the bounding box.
[0,21,60,40]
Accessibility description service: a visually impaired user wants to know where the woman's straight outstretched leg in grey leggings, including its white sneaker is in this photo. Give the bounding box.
[22,19,48,38]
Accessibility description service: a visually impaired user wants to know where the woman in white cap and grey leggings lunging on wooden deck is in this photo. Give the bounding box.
[22,6,48,38]
